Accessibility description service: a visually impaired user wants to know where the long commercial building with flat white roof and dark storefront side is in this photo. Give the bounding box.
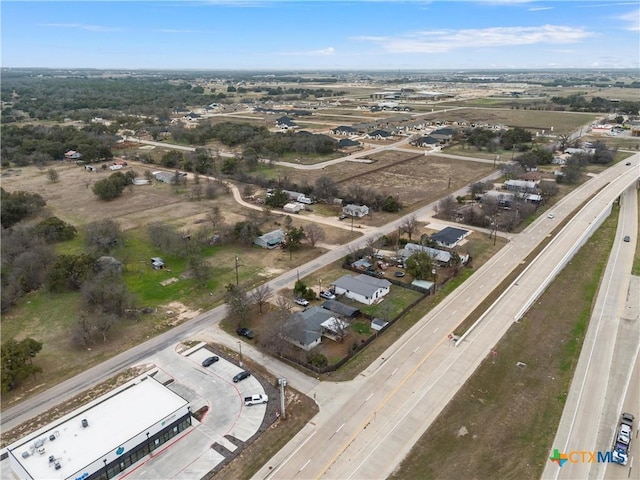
[7,375,191,480]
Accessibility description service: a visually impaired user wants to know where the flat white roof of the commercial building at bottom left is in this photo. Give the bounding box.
[8,376,188,479]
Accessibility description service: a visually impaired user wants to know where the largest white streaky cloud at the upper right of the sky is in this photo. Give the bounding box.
[356,25,593,53]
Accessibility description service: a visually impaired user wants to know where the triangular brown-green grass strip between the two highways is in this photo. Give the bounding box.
[391,205,617,479]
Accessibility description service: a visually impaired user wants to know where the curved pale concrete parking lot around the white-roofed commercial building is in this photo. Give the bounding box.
[124,343,274,479]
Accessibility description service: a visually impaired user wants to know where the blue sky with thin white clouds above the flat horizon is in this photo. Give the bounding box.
[0,0,640,71]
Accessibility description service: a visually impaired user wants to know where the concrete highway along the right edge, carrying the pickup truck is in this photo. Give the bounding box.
[542,186,640,479]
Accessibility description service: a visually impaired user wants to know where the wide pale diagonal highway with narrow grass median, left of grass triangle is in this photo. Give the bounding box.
[254,155,639,479]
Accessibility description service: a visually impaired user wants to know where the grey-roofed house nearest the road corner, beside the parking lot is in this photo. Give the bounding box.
[283,307,342,351]
